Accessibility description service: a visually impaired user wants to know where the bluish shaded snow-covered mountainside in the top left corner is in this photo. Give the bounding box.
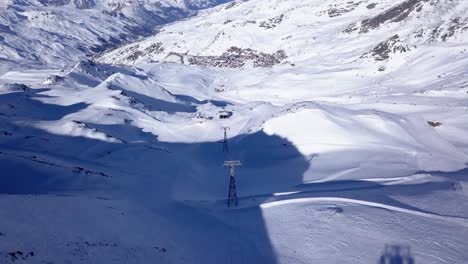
[0,0,229,71]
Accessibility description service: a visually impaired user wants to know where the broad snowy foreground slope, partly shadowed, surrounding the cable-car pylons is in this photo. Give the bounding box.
[0,57,468,263]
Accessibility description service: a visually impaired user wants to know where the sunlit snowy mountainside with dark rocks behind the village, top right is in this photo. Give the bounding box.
[102,0,468,70]
